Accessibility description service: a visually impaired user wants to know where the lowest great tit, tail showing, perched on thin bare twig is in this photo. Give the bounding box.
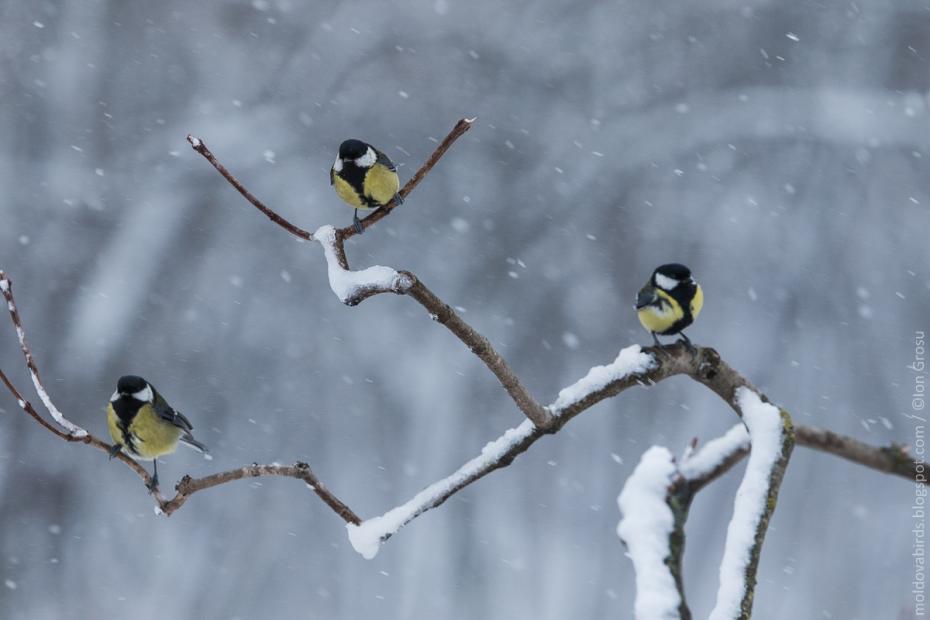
[107,375,208,490]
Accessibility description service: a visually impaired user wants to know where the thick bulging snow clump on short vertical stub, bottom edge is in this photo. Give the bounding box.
[617,446,682,620]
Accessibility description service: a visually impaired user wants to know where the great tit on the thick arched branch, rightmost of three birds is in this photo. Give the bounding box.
[636,263,704,351]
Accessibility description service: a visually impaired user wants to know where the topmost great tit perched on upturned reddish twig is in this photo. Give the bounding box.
[329,139,404,234]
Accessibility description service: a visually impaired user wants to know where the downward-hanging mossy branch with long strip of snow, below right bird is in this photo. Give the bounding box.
[710,387,794,620]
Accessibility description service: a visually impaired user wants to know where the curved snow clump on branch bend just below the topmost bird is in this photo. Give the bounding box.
[313,225,416,306]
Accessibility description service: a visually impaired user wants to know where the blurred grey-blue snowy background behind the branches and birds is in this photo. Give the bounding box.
[0,0,930,620]
